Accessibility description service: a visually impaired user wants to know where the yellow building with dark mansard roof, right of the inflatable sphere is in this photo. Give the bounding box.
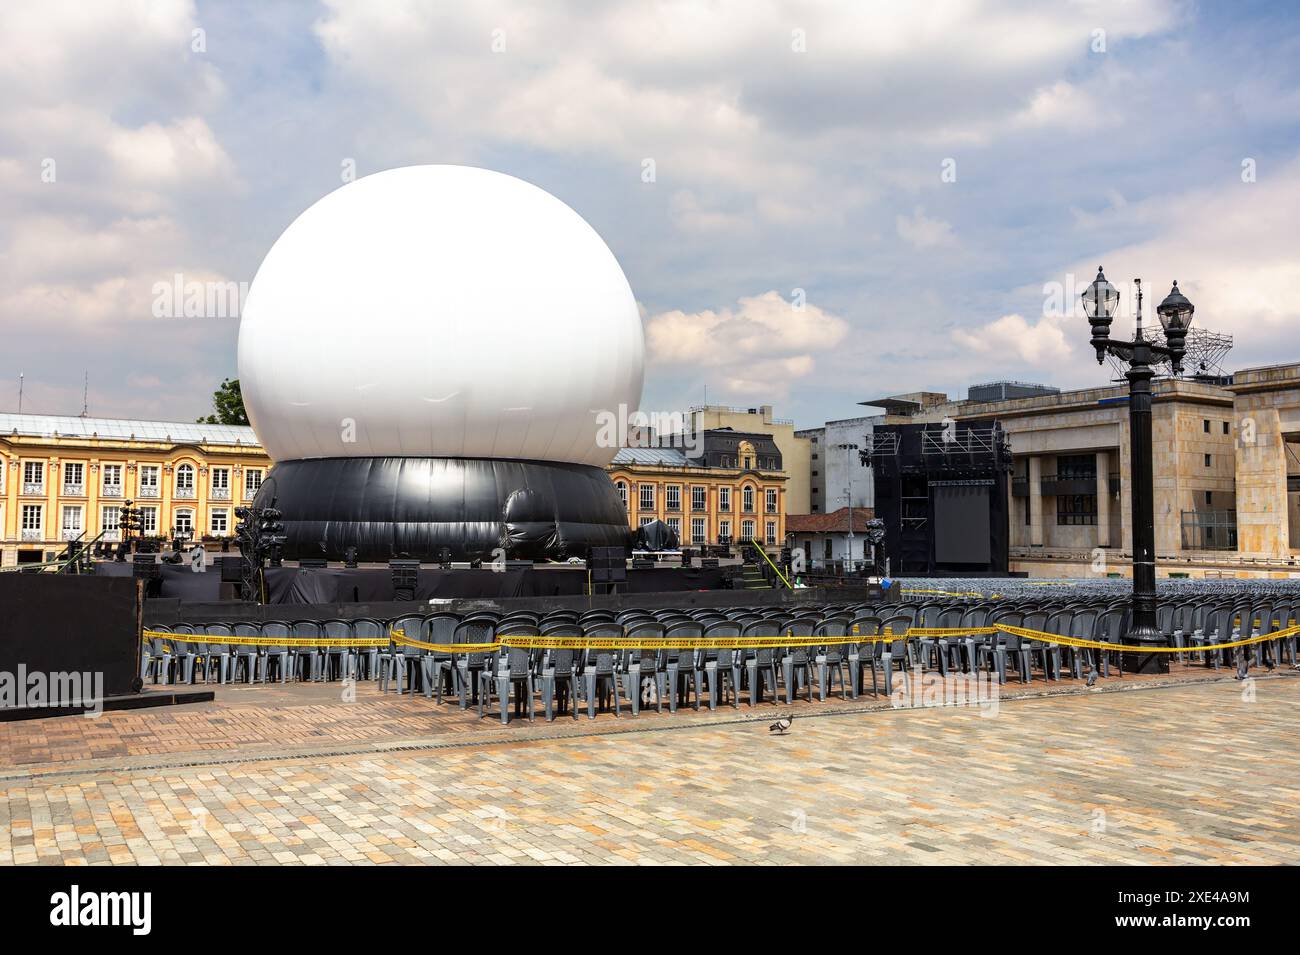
[607,427,788,550]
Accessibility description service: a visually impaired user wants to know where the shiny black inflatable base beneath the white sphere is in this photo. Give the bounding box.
[257,457,631,563]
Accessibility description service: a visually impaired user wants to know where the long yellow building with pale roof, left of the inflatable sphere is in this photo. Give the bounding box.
[0,414,270,567]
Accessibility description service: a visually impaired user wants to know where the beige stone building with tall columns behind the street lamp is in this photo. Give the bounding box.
[865,364,1300,577]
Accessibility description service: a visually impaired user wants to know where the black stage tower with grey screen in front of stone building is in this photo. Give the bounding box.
[861,420,1011,576]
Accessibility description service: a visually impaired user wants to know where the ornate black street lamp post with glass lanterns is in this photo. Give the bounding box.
[1083,268,1196,673]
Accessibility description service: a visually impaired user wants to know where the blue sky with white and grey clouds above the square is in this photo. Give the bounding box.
[0,0,1300,426]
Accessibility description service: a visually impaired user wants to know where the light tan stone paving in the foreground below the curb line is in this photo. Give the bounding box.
[0,674,1300,864]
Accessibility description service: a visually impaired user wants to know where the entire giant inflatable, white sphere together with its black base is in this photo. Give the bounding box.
[239,166,644,561]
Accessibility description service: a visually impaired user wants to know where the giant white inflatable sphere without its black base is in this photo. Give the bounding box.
[239,166,645,466]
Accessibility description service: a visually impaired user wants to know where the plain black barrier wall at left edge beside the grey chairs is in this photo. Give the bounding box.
[0,573,142,706]
